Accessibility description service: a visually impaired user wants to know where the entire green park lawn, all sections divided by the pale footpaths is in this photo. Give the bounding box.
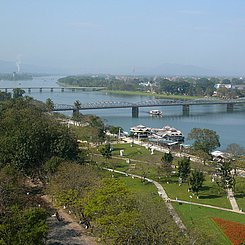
[95,144,245,245]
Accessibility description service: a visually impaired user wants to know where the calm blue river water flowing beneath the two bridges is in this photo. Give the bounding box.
[0,77,245,149]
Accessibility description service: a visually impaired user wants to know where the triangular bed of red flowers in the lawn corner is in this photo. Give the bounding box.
[212,218,245,245]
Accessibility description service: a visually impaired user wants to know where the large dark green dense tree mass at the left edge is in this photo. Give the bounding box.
[0,98,79,175]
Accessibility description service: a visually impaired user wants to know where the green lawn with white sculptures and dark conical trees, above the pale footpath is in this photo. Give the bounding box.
[97,144,241,210]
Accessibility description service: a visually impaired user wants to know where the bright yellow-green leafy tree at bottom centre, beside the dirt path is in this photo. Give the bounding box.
[84,179,139,244]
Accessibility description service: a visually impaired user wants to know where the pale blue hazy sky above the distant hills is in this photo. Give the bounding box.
[0,0,245,75]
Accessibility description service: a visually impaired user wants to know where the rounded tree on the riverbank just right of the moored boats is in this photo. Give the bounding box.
[188,128,220,154]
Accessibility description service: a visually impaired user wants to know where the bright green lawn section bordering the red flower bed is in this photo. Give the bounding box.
[173,203,245,245]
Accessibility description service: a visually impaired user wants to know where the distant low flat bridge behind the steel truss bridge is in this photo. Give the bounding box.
[0,87,106,93]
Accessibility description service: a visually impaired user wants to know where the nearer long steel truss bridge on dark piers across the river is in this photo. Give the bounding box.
[53,99,245,117]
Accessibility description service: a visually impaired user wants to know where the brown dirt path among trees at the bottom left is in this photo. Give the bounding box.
[42,195,98,245]
